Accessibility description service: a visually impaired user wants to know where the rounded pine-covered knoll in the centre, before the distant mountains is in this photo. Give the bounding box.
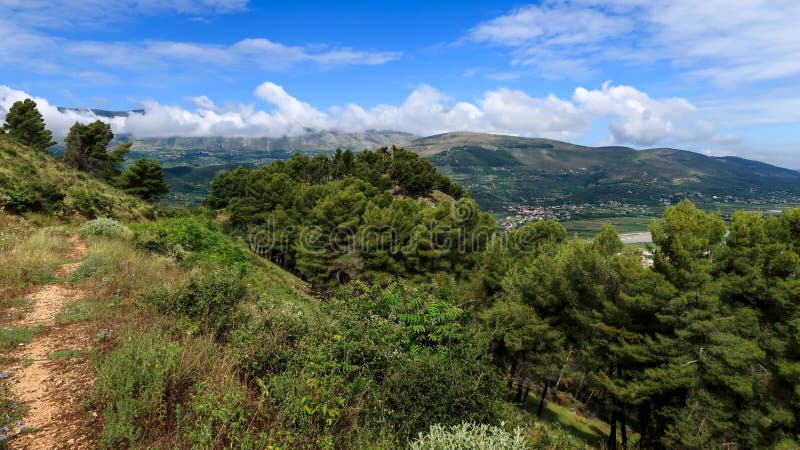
[208,148,482,285]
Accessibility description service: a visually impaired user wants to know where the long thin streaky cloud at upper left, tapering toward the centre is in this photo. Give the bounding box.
[0,19,401,77]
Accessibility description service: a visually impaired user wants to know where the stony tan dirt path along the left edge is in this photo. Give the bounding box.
[8,236,95,450]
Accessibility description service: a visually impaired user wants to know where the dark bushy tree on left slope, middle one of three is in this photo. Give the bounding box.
[64,120,132,180]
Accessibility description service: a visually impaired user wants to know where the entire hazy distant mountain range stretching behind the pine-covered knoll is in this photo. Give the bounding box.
[47,108,800,211]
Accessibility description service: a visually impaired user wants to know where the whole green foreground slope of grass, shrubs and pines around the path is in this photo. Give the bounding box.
[0,127,800,449]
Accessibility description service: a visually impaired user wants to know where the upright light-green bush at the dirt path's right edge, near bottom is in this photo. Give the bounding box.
[91,333,180,448]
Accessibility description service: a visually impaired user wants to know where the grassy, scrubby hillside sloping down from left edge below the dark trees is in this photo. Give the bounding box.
[0,136,151,219]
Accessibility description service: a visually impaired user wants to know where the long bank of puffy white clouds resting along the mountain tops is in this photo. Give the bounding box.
[0,82,716,145]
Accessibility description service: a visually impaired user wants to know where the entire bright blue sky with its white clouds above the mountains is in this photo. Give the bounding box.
[0,0,800,168]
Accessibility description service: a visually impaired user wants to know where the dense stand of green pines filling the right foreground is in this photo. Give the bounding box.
[482,201,800,448]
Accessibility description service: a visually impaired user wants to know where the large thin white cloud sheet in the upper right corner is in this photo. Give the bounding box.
[467,0,800,85]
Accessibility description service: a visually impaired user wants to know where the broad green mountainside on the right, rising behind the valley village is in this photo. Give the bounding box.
[406,132,800,211]
